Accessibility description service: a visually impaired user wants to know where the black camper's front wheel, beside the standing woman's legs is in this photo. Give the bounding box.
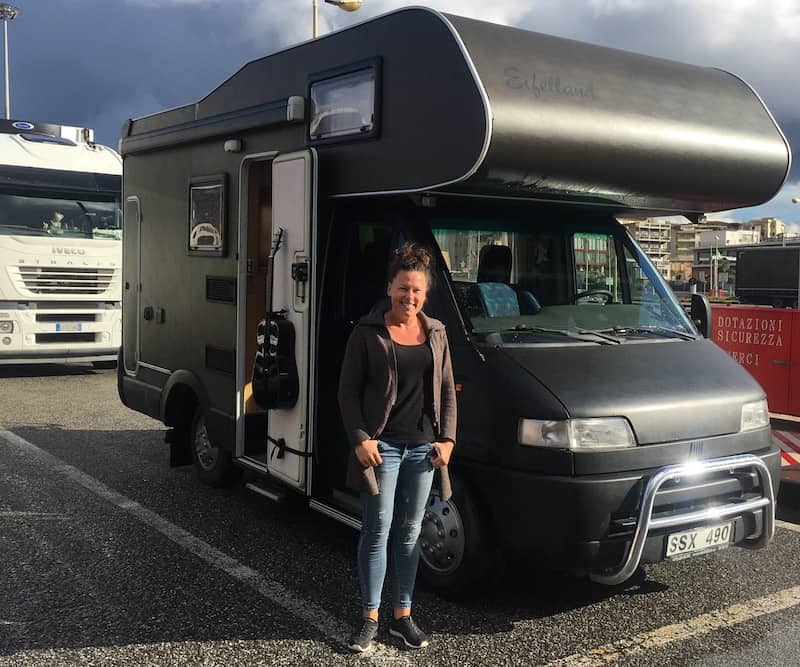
[419,473,500,596]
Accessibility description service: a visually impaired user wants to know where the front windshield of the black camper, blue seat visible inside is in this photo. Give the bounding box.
[431,218,697,344]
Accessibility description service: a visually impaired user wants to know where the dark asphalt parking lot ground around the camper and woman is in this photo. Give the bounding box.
[0,366,800,667]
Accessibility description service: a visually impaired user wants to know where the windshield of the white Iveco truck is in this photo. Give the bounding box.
[0,194,122,241]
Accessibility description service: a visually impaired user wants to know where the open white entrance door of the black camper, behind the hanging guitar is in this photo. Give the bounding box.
[266,150,316,488]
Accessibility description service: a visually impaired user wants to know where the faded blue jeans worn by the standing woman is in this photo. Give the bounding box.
[358,440,433,610]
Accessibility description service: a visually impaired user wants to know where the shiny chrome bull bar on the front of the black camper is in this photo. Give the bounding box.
[590,454,775,585]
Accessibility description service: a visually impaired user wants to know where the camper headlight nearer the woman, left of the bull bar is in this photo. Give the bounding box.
[517,417,636,450]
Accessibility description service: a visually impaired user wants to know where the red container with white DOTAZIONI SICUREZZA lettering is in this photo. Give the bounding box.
[711,304,800,416]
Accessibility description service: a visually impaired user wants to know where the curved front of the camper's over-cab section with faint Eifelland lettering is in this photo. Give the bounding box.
[448,16,790,213]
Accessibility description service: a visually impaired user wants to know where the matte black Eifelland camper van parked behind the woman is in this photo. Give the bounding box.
[118,8,790,591]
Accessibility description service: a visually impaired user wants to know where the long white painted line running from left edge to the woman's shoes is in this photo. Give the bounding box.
[0,429,409,665]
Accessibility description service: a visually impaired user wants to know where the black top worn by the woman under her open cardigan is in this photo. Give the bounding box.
[380,341,435,445]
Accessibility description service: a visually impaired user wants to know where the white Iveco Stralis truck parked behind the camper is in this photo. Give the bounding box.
[0,120,122,366]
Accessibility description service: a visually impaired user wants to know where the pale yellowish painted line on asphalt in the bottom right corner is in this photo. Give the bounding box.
[548,586,800,667]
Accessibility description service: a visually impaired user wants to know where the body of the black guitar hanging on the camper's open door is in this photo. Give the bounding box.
[253,313,300,410]
